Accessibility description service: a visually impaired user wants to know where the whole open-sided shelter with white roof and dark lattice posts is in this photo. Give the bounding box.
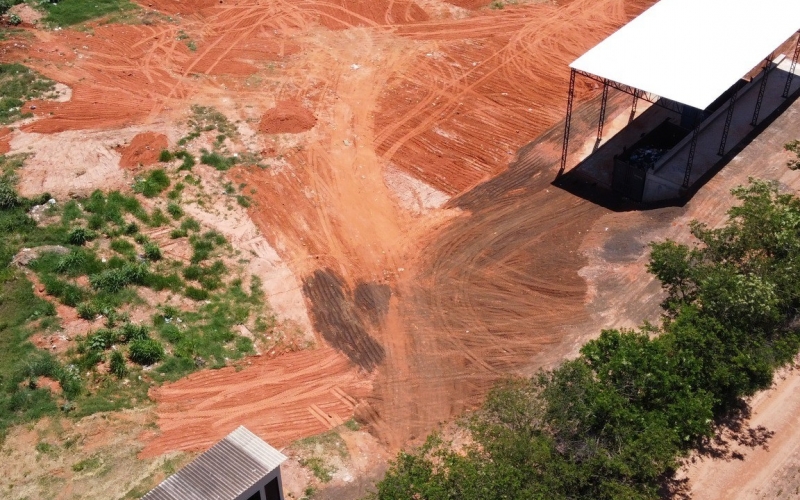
[559,0,800,202]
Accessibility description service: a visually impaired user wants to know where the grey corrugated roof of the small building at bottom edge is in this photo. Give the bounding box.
[142,426,286,500]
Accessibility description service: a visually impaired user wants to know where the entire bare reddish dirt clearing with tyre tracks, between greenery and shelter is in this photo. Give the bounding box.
[0,0,798,497]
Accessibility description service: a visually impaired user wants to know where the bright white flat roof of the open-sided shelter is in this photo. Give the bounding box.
[570,0,800,109]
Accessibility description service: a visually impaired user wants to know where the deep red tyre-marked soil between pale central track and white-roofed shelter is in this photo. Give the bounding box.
[375,0,652,194]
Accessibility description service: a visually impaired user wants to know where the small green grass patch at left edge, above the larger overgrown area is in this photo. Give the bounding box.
[0,63,55,124]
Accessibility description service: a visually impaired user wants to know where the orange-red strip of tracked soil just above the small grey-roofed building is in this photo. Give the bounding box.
[141,347,372,457]
